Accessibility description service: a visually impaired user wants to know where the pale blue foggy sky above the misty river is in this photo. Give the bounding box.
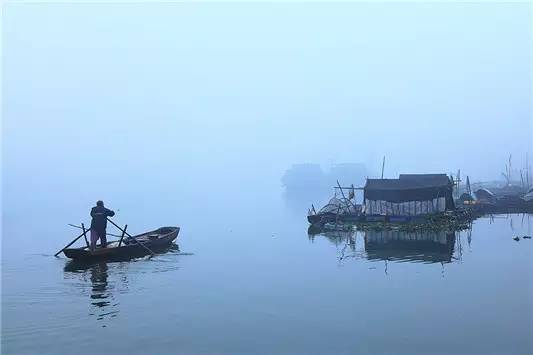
[2,2,533,211]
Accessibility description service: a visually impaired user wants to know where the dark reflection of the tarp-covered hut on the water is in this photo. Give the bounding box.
[365,230,455,263]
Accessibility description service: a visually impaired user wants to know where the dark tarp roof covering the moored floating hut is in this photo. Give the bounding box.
[364,174,455,210]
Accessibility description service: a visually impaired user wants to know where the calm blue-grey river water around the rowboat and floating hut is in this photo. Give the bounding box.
[2,187,533,354]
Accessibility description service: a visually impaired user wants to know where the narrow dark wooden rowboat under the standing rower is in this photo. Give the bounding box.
[63,227,180,261]
